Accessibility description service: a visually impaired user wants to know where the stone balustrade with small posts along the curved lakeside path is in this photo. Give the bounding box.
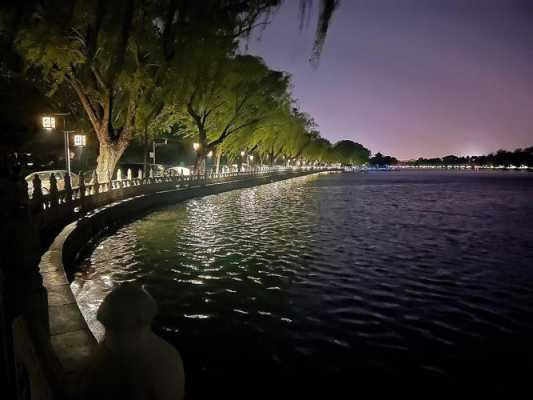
[29,167,328,232]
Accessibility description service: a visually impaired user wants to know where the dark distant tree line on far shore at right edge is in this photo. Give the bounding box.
[407,147,533,168]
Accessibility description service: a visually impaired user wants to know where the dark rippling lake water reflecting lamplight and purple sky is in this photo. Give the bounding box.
[72,171,533,399]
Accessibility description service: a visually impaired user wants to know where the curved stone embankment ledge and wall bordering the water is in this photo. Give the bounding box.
[30,170,335,398]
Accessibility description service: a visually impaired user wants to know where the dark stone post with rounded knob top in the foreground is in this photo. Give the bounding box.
[80,284,185,400]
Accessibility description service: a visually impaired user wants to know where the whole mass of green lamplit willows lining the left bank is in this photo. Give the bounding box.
[0,0,350,176]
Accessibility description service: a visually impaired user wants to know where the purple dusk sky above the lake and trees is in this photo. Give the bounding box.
[243,0,533,159]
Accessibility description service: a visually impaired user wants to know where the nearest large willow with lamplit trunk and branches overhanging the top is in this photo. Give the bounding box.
[0,0,337,181]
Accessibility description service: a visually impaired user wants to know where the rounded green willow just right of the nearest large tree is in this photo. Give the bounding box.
[180,55,289,169]
